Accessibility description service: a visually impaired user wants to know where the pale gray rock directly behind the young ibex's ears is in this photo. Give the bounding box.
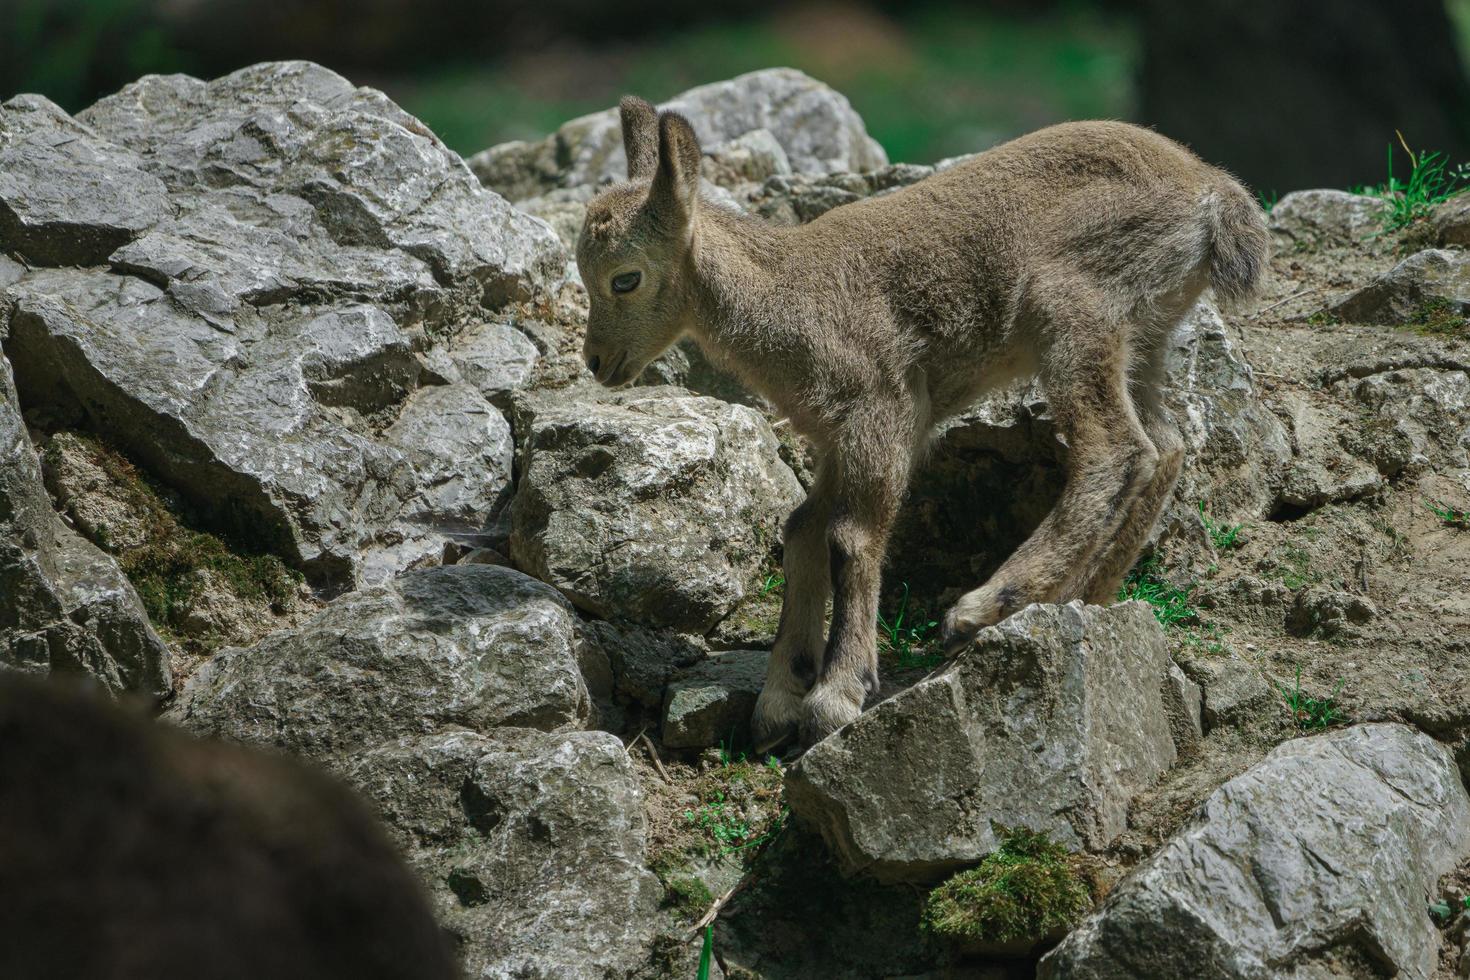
[469,68,888,201]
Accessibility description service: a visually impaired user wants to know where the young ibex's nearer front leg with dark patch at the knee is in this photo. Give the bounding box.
[801,411,913,745]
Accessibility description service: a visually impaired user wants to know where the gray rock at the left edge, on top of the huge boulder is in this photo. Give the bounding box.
[0,96,168,266]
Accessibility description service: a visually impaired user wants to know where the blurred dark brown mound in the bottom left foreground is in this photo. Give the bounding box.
[0,673,459,980]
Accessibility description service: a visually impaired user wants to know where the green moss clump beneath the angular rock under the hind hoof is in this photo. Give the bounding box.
[920,824,1092,943]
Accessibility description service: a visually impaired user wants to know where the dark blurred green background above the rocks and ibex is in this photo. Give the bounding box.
[0,0,1470,197]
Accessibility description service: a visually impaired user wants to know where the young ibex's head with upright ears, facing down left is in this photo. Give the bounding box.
[576,96,700,386]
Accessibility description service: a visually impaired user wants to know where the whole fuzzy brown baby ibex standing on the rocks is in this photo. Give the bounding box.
[576,97,1269,745]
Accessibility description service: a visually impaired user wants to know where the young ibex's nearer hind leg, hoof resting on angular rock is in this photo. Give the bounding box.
[944,292,1160,654]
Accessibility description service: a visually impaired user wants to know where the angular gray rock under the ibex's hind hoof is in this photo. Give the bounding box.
[786,602,1176,882]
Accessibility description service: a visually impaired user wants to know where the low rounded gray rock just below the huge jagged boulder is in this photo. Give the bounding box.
[169,564,591,761]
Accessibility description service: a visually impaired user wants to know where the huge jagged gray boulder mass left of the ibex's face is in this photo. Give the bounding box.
[0,62,564,588]
